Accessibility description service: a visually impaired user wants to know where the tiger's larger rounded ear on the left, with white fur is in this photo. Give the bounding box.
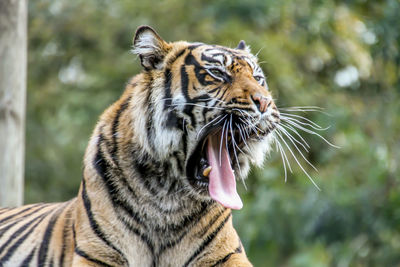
[132,25,171,70]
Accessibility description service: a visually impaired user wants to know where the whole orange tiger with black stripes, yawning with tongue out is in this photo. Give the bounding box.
[0,25,280,267]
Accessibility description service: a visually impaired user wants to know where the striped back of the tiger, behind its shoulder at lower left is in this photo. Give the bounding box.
[0,200,75,267]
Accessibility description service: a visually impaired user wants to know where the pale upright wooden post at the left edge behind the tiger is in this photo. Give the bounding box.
[0,0,27,207]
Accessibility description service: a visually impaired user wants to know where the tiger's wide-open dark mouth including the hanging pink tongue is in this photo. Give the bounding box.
[186,115,265,209]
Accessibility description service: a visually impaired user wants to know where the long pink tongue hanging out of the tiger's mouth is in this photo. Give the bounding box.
[207,132,243,210]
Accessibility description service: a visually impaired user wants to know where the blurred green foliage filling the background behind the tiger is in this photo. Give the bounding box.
[26,0,400,266]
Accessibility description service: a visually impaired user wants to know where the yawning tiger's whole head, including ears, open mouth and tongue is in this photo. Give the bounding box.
[133,26,280,209]
